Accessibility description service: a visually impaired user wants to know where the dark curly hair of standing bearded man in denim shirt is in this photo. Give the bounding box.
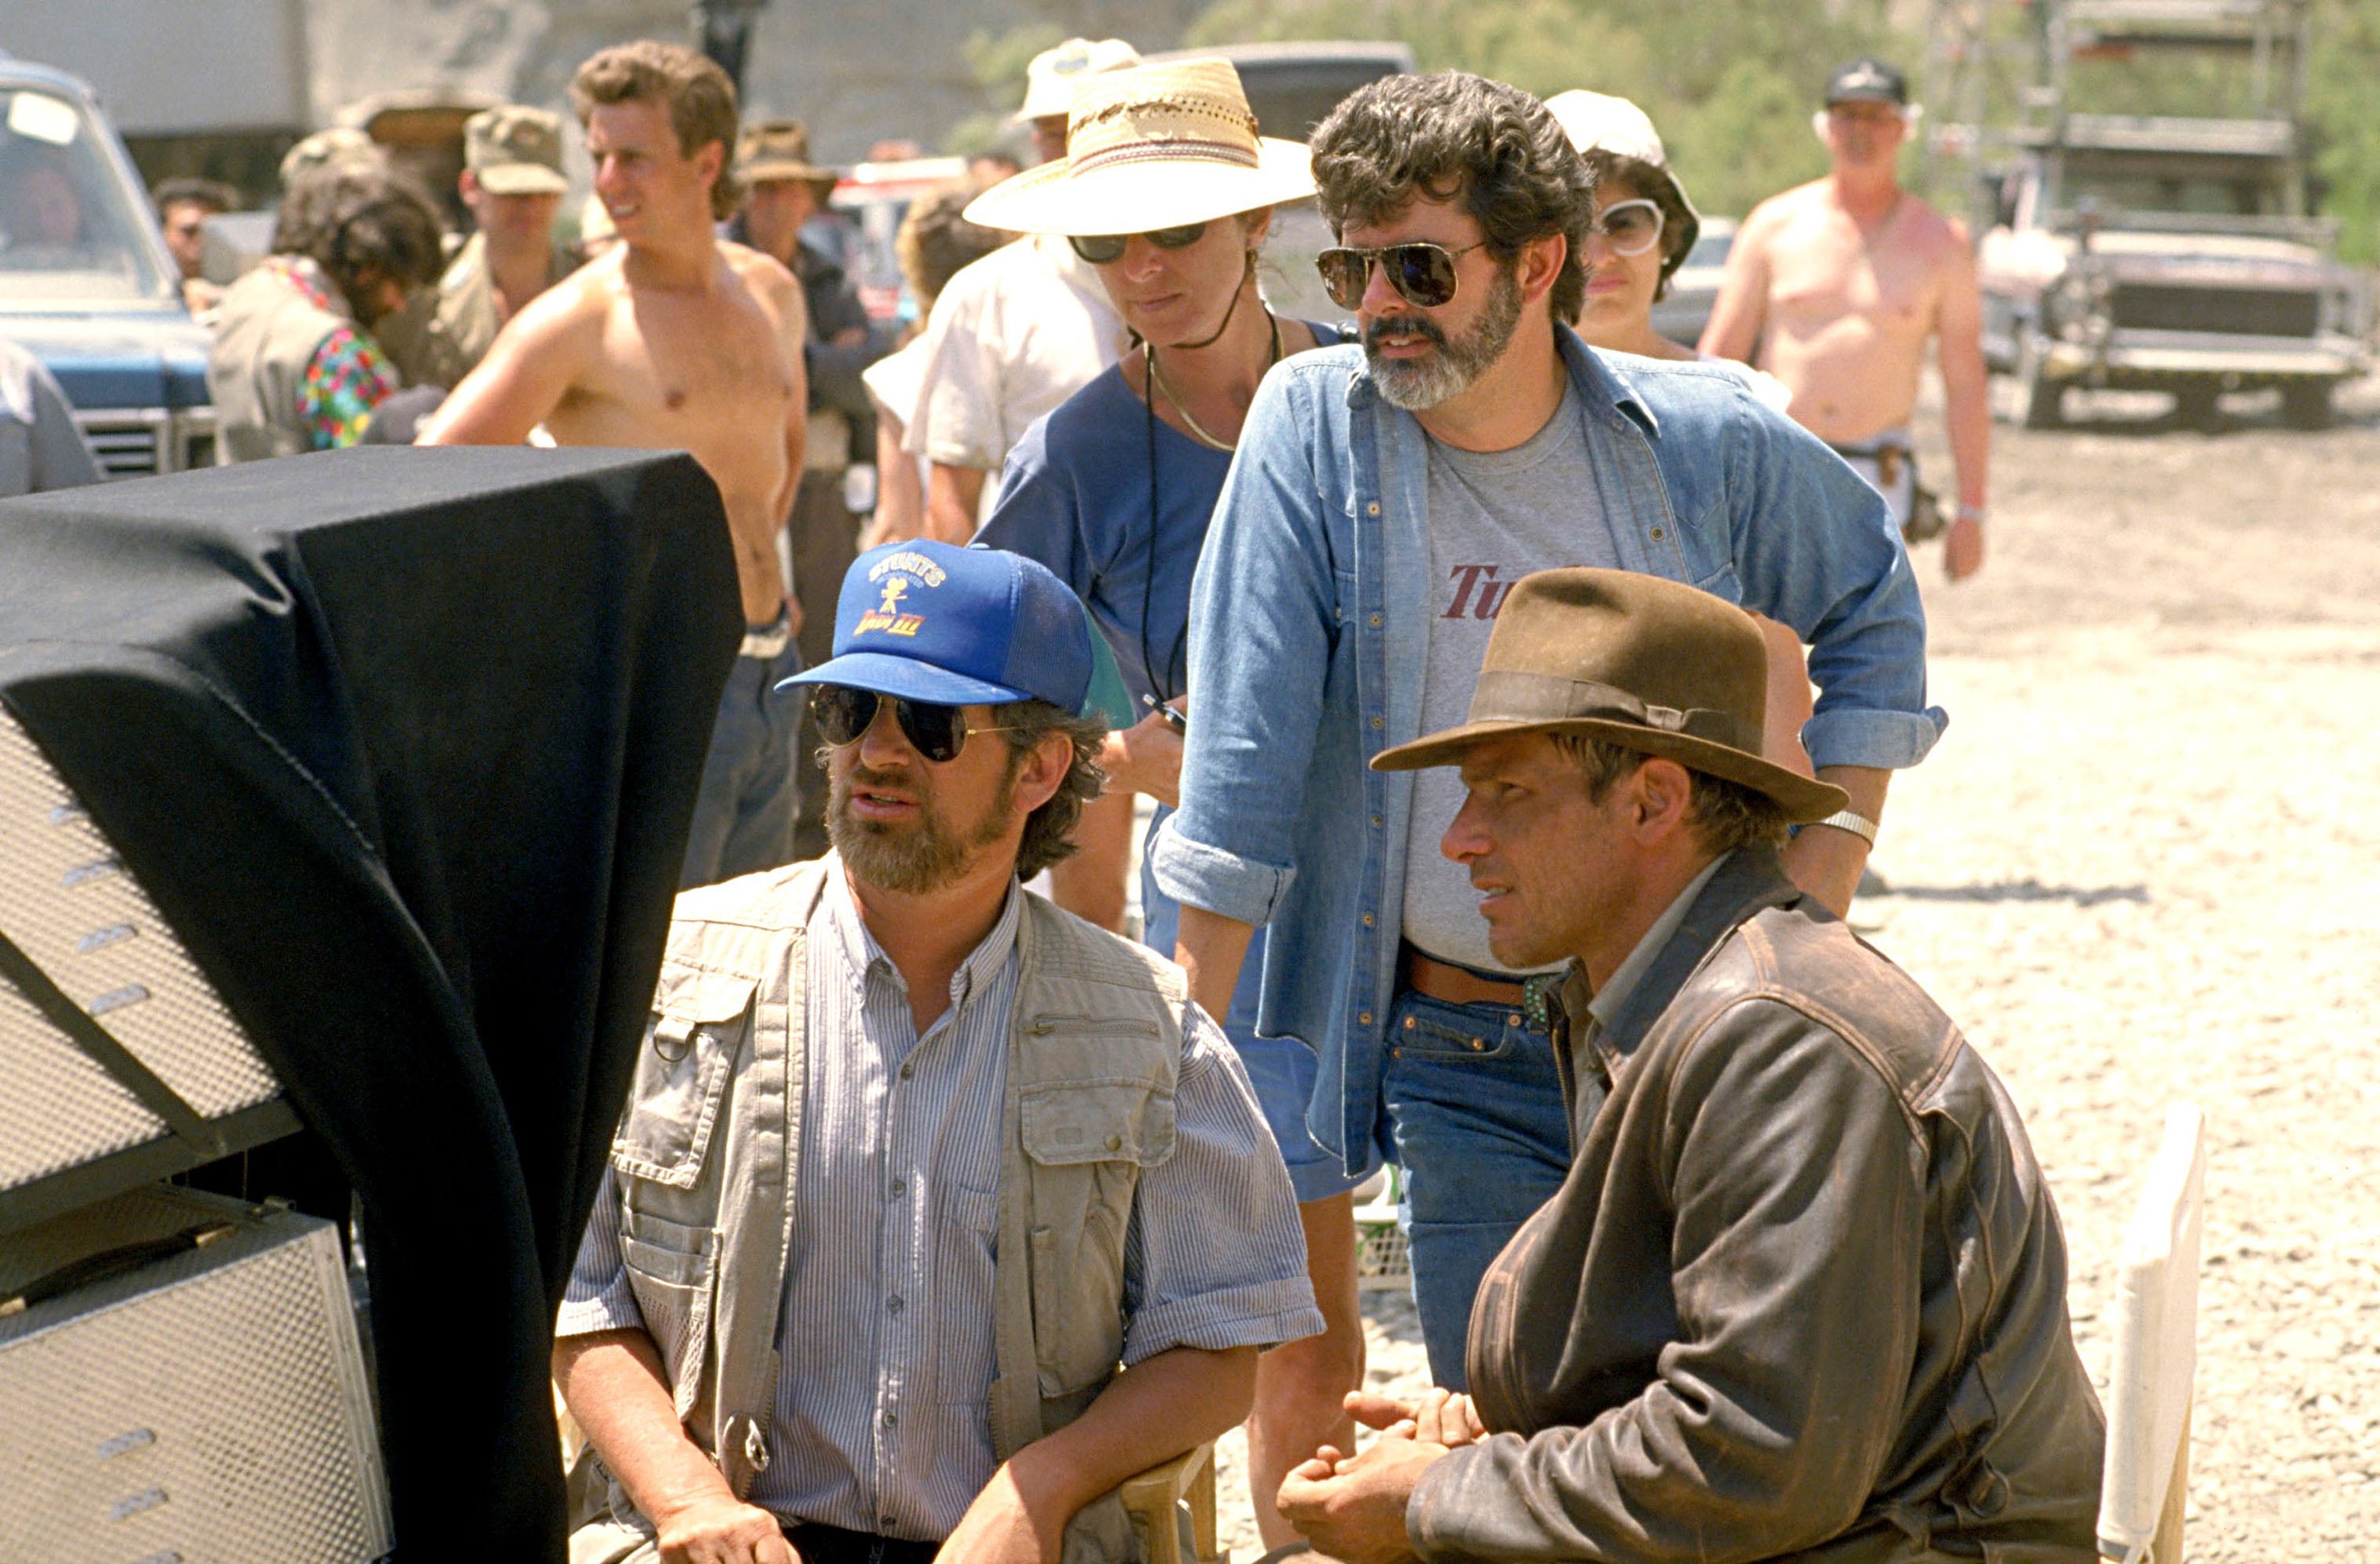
[1309,71,1594,322]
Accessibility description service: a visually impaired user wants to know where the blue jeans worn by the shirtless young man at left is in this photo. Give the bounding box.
[678,640,805,875]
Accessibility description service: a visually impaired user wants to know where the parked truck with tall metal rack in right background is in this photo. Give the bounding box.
[1978,0,2371,428]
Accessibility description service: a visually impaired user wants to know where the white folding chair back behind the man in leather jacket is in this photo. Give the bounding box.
[2099,1102,2206,1564]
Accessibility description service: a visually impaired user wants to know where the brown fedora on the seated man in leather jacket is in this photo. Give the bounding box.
[1371,569,1851,824]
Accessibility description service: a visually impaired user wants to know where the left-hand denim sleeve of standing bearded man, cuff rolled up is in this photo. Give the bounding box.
[1150,362,1338,926]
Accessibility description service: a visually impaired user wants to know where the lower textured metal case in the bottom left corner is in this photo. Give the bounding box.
[0,1191,393,1564]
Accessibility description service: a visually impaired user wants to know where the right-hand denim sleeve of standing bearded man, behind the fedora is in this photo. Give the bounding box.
[1728,395,1949,769]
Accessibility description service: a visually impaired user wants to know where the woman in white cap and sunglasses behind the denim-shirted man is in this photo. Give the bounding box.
[1545,90,1814,776]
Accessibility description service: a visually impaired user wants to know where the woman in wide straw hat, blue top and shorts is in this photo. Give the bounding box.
[966,60,1364,1545]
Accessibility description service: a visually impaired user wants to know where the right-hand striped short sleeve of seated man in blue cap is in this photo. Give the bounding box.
[1124,1005,1323,1366]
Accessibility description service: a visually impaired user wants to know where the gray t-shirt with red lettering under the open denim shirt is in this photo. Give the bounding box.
[1404,386,1619,971]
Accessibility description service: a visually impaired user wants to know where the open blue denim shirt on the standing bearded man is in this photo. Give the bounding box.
[1152,329,1947,1169]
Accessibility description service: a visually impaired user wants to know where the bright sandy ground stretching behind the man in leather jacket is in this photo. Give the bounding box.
[1221,386,2380,1564]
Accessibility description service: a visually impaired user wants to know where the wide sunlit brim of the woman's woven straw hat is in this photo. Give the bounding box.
[964,136,1314,238]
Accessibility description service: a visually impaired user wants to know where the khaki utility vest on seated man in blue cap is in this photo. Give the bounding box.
[612,860,1185,1564]
